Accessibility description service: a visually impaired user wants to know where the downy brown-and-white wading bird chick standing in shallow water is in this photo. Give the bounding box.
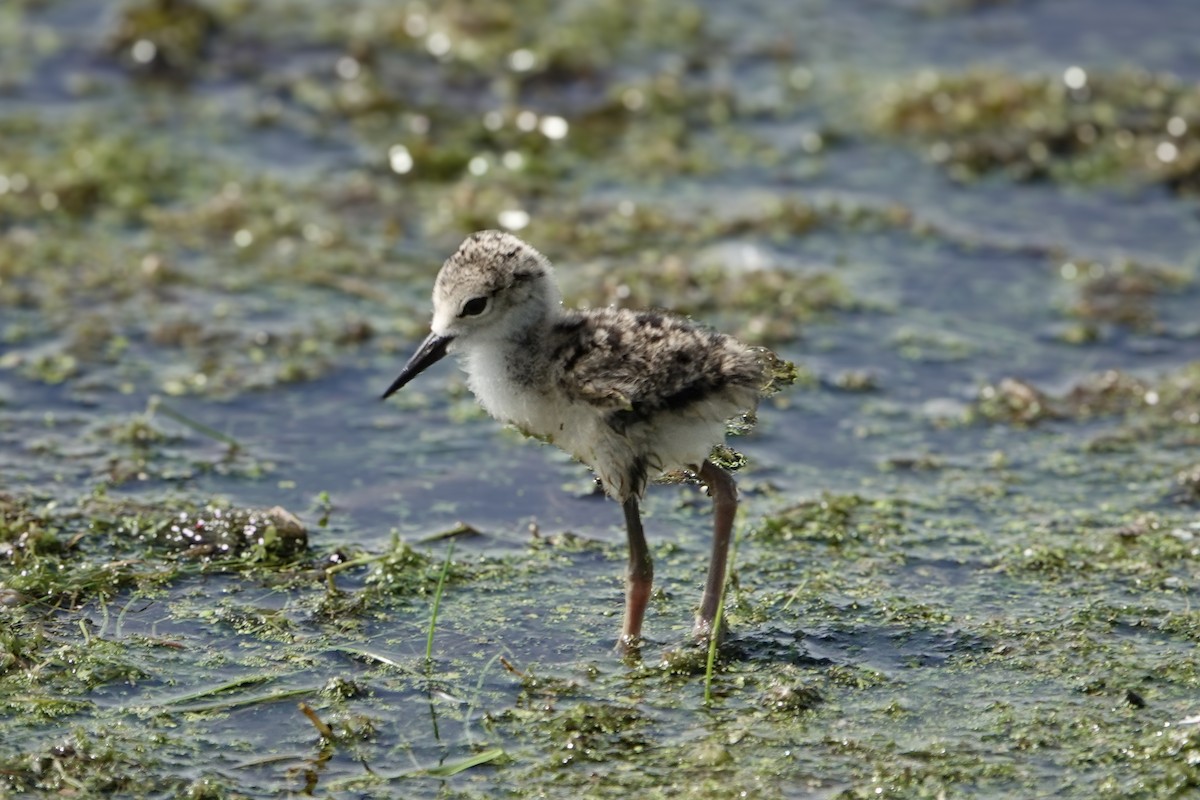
[383,230,774,650]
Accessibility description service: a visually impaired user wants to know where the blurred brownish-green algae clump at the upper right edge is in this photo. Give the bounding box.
[875,66,1200,193]
